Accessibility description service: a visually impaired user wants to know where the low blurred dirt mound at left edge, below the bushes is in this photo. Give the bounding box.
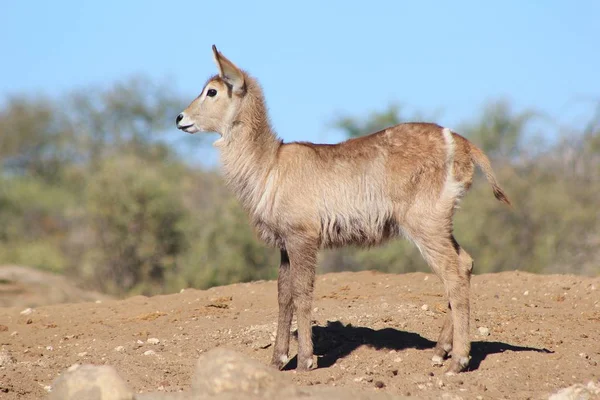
[0,265,110,307]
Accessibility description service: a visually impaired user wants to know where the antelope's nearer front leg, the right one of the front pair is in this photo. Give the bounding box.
[288,239,317,371]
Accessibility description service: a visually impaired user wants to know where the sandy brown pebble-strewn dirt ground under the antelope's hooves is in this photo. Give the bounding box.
[0,272,600,400]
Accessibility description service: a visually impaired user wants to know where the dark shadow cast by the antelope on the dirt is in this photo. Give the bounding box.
[284,321,553,370]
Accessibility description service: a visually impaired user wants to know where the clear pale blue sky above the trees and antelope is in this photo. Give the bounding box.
[0,0,600,148]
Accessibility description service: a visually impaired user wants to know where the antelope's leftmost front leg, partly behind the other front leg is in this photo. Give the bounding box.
[271,250,293,369]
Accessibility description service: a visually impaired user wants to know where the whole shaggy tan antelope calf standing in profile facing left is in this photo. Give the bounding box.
[177,46,510,373]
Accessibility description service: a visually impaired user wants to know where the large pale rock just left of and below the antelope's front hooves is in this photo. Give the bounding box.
[192,348,290,397]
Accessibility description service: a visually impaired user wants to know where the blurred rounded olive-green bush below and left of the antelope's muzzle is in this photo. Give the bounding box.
[83,156,186,293]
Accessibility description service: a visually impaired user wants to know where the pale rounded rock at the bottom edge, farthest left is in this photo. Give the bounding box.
[48,365,134,400]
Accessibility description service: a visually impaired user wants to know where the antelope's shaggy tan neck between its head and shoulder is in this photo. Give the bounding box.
[218,76,282,214]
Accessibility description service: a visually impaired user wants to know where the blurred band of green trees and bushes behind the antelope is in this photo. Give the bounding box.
[0,78,600,294]
